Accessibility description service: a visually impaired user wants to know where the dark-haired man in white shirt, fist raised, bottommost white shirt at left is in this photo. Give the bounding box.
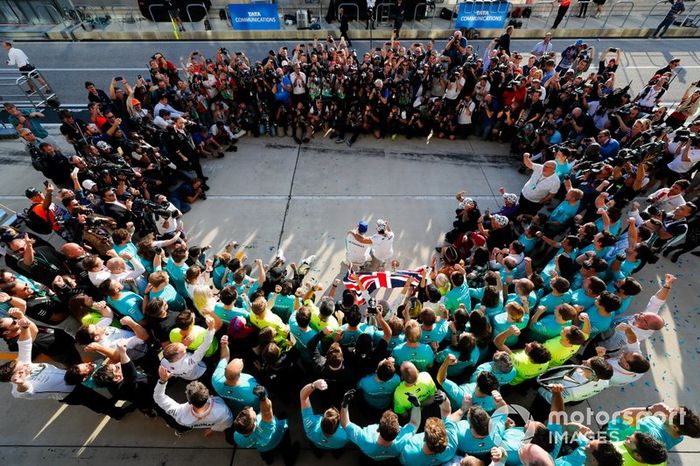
[153,366,233,437]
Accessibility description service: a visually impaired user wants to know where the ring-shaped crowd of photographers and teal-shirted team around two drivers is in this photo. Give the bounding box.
[0,30,700,466]
